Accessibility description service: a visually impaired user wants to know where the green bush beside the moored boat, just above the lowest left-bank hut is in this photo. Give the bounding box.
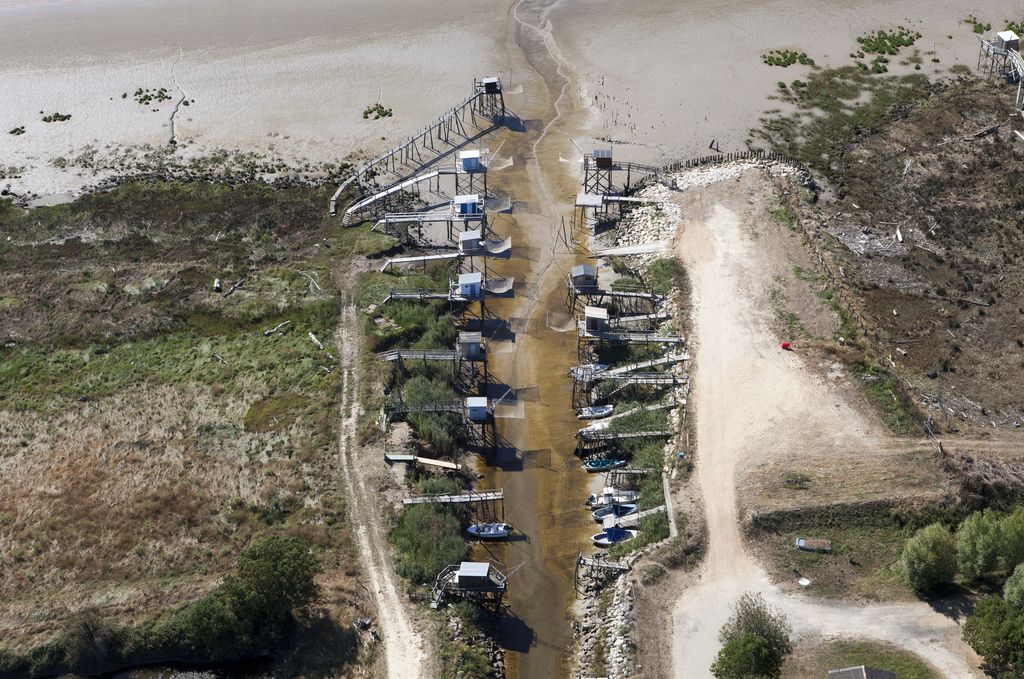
[390,503,466,585]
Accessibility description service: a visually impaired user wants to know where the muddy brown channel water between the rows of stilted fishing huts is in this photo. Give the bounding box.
[480,1,594,678]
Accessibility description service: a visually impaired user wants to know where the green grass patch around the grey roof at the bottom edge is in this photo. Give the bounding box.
[781,640,941,679]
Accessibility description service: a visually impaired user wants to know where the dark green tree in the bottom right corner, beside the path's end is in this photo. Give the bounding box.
[964,596,1024,677]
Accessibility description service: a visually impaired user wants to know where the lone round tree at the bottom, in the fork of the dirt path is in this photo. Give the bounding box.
[716,592,793,677]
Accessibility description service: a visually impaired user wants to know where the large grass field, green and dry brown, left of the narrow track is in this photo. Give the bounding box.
[0,182,376,672]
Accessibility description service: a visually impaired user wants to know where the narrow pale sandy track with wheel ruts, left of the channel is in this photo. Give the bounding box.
[335,303,426,679]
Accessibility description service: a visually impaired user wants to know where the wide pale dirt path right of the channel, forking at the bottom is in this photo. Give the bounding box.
[673,174,980,679]
